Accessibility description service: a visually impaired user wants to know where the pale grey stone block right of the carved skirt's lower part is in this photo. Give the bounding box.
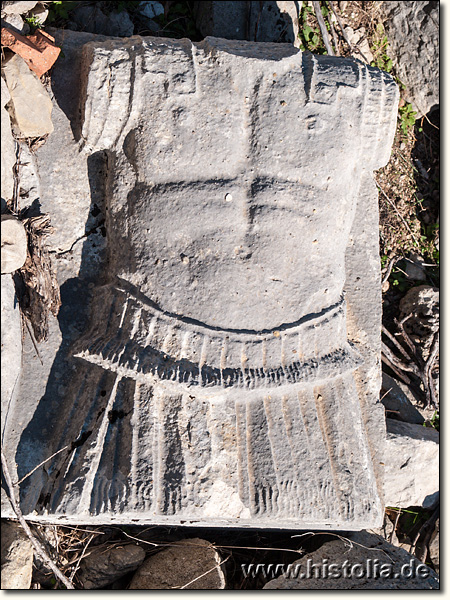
[385,419,439,508]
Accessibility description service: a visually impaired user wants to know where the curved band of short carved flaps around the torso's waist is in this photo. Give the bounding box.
[75,282,363,389]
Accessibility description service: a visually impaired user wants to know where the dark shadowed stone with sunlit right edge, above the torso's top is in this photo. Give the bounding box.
[194,1,302,47]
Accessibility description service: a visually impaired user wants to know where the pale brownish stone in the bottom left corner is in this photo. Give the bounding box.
[1,520,33,590]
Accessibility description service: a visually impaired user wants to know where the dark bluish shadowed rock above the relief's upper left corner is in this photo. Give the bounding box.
[71,2,134,37]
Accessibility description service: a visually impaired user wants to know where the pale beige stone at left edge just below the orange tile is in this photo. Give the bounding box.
[2,54,53,138]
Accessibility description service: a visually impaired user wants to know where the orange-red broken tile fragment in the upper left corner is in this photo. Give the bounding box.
[2,27,61,77]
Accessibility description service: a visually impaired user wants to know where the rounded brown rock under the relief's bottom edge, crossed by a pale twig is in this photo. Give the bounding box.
[129,538,226,590]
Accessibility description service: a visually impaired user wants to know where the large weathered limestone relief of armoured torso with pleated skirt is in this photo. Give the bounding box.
[2,34,398,529]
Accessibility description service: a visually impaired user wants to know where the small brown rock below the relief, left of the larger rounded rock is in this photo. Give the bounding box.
[78,544,145,590]
